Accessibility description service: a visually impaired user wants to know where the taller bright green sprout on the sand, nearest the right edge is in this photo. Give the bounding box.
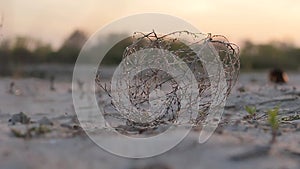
[267,106,279,143]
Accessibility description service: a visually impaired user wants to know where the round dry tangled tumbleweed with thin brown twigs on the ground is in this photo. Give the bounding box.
[96,30,240,126]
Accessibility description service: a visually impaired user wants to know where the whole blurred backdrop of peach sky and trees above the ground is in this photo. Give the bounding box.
[0,0,300,78]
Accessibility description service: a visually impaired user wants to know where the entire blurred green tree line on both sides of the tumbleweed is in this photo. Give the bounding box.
[0,30,300,75]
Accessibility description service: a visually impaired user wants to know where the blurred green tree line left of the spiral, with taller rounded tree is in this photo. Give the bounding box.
[0,30,87,75]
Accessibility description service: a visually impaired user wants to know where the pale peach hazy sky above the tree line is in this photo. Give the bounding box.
[0,0,300,46]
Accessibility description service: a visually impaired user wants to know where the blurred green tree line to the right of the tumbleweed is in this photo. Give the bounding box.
[240,41,300,71]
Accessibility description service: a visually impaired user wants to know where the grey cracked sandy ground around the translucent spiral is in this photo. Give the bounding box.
[0,73,300,169]
